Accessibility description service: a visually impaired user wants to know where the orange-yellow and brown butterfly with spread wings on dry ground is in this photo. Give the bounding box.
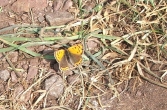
[54,44,83,71]
